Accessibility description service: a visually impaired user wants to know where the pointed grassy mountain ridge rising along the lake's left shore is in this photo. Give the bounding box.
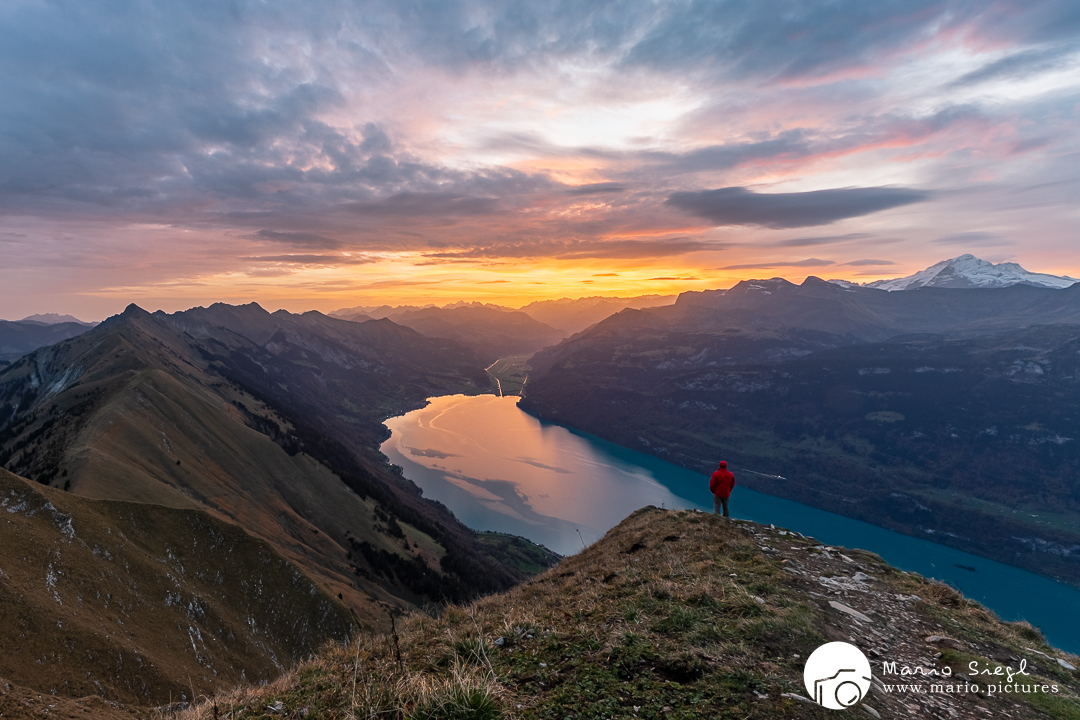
[0,305,523,625]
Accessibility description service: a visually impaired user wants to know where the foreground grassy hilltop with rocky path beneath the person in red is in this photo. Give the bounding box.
[172,507,1080,720]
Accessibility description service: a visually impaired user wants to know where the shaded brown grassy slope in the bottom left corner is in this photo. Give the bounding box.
[0,470,349,717]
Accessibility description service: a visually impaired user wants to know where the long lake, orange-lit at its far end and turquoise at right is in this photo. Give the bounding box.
[382,395,1080,652]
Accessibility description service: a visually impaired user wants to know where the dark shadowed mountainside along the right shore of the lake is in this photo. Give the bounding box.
[521,279,1080,582]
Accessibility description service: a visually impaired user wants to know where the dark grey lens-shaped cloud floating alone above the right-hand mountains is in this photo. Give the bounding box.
[666,187,931,228]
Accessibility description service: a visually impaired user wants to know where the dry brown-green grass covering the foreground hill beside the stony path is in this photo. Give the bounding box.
[168,508,1074,720]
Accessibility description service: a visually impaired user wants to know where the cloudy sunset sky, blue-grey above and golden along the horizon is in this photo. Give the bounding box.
[0,0,1080,320]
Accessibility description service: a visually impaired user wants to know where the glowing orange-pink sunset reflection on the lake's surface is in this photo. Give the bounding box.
[382,395,691,555]
